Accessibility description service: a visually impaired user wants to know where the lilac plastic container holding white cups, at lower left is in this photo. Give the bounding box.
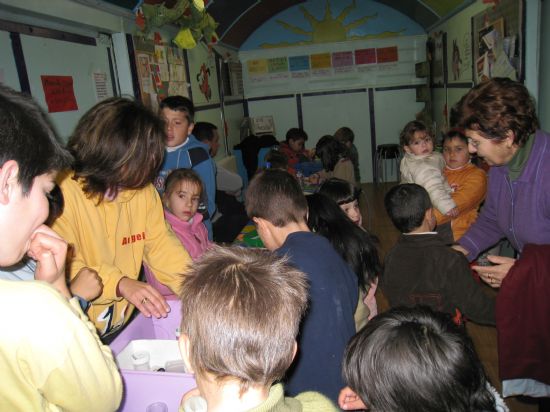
[109,300,196,412]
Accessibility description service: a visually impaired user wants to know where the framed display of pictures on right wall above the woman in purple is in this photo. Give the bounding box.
[472,0,524,84]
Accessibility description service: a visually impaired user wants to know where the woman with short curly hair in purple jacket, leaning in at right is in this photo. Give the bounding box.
[454,78,550,288]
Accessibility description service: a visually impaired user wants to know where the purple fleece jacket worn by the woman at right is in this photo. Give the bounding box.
[459,130,550,261]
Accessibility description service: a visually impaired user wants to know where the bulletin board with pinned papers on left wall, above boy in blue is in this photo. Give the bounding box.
[133,36,189,111]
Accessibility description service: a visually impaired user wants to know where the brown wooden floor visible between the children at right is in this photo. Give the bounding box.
[361,182,546,412]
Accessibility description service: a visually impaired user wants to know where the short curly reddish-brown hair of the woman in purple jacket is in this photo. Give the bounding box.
[454,77,539,146]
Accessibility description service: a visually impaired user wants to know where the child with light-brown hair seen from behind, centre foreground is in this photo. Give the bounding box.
[179,247,337,412]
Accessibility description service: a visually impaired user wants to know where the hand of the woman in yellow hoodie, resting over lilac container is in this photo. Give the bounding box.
[118,277,170,319]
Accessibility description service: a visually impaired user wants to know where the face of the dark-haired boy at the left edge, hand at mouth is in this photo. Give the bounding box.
[0,169,56,266]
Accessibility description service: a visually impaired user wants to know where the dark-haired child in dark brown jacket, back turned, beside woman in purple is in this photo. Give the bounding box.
[381,184,495,325]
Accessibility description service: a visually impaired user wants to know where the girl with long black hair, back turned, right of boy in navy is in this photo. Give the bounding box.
[306,193,382,330]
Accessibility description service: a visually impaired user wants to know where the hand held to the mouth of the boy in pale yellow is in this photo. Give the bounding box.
[27,225,71,298]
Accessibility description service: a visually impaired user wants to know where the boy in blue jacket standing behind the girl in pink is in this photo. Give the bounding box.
[155,96,216,240]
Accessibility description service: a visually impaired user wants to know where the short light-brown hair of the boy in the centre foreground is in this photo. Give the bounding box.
[180,247,307,393]
